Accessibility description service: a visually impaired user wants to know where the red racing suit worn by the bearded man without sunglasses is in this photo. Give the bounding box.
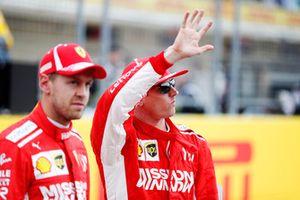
[0,103,89,200]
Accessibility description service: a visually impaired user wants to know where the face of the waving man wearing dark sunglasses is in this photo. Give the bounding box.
[142,79,178,119]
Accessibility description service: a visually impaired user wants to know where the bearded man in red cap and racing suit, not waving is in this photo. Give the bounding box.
[0,44,106,200]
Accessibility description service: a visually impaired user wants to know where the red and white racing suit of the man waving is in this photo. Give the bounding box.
[91,52,218,200]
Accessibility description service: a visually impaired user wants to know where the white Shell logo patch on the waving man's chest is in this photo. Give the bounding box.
[138,139,159,161]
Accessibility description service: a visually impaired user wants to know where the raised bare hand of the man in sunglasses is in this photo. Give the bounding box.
[165,10,214,63]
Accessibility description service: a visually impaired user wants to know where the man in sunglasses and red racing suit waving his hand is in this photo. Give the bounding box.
[91,11,218,200]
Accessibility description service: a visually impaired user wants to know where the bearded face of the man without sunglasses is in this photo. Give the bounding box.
[47,71,93,124]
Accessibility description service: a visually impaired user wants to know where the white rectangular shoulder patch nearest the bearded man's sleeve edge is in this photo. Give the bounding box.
[6,120,37,143]
